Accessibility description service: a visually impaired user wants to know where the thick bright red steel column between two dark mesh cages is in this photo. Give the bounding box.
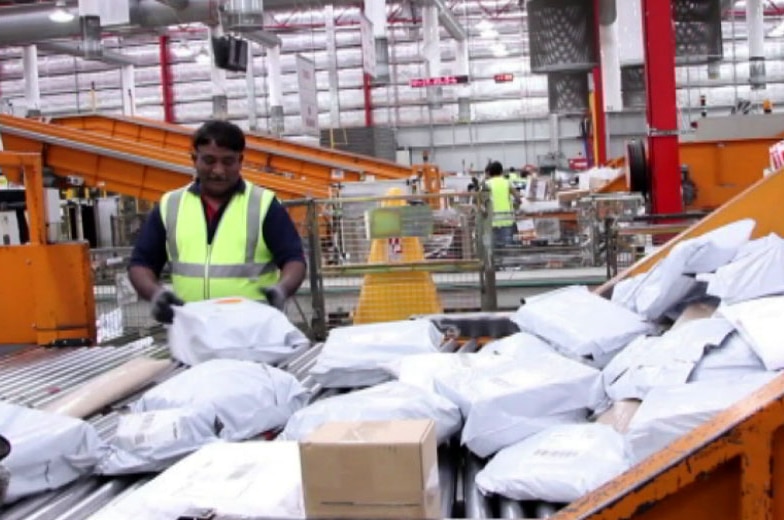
[642,0,683,214]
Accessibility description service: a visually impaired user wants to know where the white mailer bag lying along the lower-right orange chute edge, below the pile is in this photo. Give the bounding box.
[626,372,777,463]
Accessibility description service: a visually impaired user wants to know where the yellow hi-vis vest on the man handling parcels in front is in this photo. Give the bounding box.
[160,183,279,302]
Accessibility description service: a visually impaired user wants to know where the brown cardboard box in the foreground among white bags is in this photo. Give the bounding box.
[300,420,441,519]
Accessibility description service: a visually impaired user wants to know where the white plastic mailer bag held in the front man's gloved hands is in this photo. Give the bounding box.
[168,298,309,365]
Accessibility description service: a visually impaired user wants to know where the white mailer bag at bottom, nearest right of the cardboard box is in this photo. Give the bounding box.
[476,423,629,503]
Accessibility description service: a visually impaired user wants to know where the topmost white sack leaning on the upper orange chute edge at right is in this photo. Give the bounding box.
[634,219,756,320]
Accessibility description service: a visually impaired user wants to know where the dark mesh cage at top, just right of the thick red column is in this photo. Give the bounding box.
[672,0,723,64]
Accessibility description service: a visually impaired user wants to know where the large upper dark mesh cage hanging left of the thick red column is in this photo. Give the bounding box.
[526,0,596,73]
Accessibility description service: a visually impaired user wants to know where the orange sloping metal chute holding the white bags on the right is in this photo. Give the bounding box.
[552,170,784,520]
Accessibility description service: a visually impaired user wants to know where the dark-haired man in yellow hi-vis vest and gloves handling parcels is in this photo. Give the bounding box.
[128,121,306,323]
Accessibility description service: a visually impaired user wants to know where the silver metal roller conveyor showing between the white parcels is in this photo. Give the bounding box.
[0,338,555,520]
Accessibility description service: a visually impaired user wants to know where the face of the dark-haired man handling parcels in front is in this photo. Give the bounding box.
[192,142,242,197]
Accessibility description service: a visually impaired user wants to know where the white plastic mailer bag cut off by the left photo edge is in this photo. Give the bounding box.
[0,402,105,503]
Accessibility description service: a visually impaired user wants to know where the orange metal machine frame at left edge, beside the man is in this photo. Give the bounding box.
[0,152,96,345]
